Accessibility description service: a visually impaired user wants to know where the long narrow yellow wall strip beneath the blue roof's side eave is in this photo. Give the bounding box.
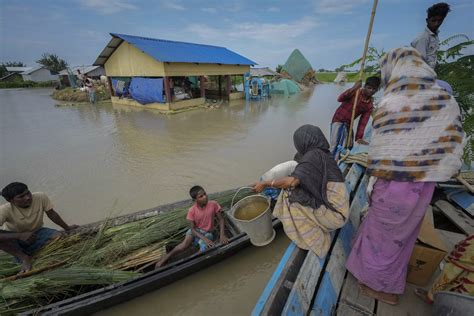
[164,63,250,77]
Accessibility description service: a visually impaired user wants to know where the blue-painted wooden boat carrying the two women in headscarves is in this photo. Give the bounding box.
[252,149,474,316]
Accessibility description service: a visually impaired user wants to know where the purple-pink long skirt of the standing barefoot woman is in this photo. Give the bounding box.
[346,179,435,294]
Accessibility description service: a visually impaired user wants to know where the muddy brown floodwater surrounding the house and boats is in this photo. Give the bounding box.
[0,85,344,315]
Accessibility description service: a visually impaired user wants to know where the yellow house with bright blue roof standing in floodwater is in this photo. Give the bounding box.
[94,33,256,110]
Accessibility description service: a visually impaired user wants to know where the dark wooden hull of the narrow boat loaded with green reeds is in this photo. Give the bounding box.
[18,190,280,315]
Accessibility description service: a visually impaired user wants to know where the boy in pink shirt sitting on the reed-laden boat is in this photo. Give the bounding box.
[155,185,229,268]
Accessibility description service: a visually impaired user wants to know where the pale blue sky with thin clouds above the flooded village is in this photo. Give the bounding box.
[0,0,474,69]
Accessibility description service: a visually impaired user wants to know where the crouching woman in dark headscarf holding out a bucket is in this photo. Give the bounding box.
[254,125,349,257]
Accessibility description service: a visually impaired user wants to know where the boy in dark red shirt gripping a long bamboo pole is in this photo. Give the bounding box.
[330,77,380,160]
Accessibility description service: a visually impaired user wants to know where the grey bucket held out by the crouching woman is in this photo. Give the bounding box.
[230,187,276,246]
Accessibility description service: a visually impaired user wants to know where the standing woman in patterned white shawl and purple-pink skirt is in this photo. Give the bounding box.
[346,48,464,304]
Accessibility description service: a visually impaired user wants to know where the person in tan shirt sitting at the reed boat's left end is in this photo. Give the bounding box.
[0,182,77,272]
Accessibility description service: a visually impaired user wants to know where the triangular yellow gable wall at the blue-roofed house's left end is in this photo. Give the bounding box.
[104,42,165,77]
